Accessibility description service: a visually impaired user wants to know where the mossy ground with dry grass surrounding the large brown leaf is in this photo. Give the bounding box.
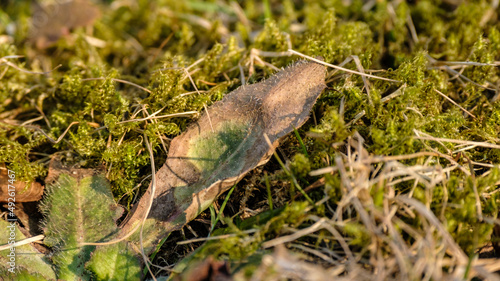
[0,0,500,280]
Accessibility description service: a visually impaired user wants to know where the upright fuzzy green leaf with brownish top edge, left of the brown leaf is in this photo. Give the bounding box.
[43,170,129,280]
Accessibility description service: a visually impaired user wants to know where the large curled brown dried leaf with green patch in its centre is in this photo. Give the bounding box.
[122,61,325,251]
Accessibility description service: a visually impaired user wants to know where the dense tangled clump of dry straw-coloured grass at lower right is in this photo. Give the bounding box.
[294,134,499,280]
